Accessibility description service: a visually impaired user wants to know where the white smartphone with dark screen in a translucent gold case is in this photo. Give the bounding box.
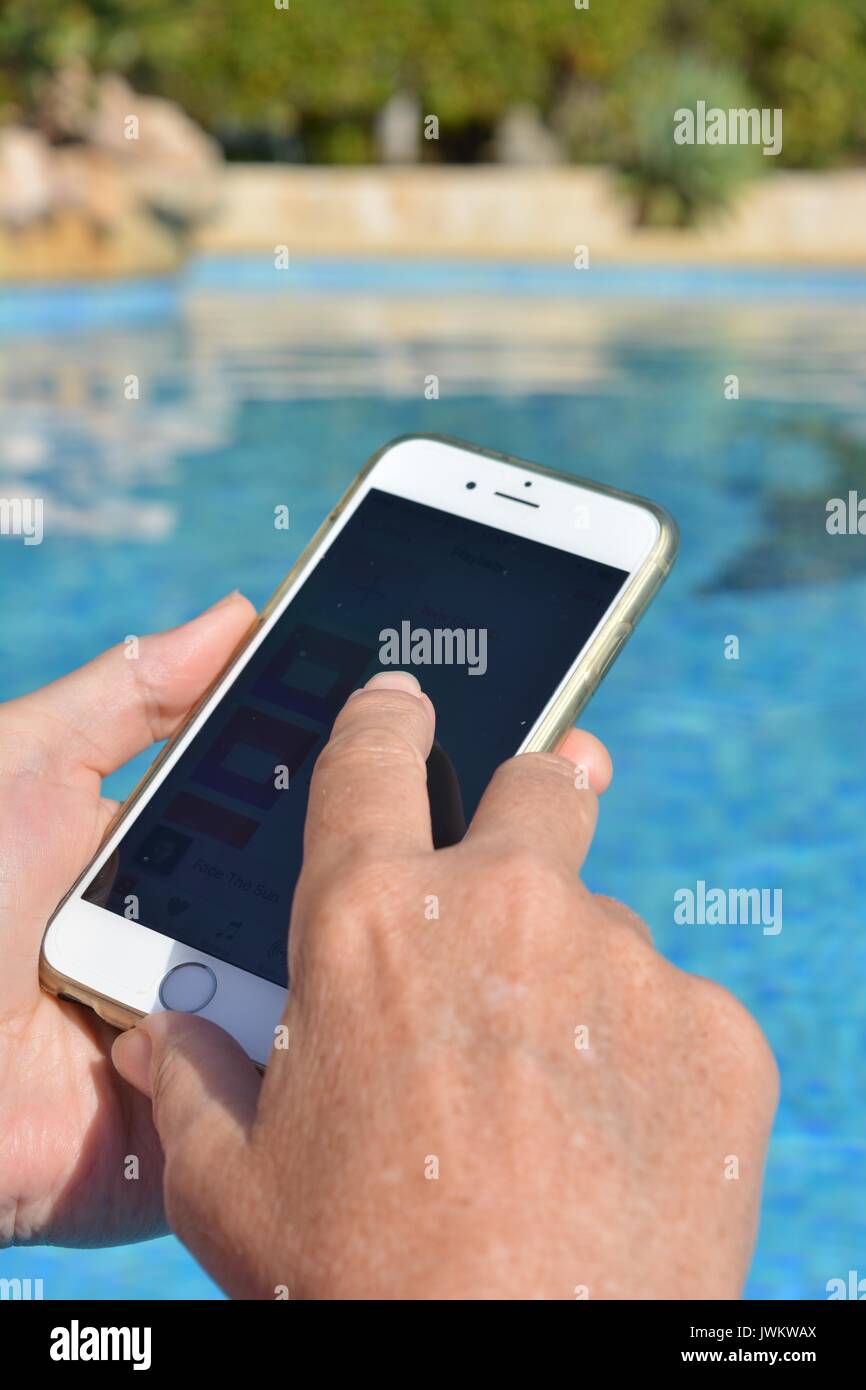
[40,435,677,1065]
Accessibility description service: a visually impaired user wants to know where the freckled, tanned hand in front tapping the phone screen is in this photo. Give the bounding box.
[114,673,777,1298]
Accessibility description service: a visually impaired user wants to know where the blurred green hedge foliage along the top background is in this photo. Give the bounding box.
[0,0,866,177]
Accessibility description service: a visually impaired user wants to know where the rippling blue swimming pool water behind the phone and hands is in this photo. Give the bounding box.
[0,261,866,1298]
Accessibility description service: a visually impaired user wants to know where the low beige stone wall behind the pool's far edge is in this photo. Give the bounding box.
[196,165,866,265]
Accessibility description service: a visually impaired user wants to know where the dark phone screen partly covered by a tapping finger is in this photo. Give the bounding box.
[83,489,628,986]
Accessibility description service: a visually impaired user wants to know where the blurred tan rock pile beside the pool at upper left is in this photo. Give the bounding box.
[0,64,221,279]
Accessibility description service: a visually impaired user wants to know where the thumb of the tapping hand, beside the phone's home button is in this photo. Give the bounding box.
[111,1012,261,1293]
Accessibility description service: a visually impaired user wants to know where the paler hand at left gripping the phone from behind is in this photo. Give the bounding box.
[0,595,254,1245]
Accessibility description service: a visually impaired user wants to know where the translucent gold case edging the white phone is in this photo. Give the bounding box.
[39,434,680,1029]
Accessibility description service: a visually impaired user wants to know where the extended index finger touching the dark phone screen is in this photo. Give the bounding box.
[304,671,435,869]
